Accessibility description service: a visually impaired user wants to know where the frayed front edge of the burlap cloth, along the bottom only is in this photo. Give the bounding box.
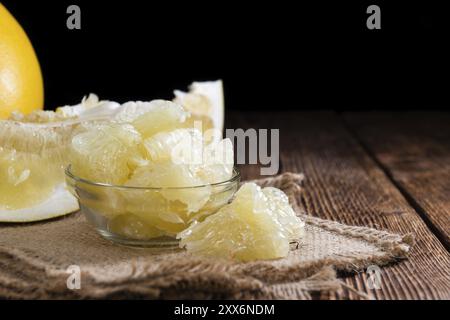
[0,242,340,299]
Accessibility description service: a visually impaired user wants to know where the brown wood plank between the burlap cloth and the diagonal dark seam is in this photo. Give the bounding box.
[228,112,450,299]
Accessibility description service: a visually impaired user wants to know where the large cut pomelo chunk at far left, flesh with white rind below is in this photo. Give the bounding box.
[0,120,78,222]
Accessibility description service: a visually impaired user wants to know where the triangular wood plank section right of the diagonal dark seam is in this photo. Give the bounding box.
[344,112,450,250]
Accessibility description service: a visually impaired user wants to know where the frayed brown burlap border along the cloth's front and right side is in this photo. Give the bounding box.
[0,173,413,299]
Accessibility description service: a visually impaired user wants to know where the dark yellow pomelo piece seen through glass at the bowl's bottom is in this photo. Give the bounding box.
[108,214,164,240]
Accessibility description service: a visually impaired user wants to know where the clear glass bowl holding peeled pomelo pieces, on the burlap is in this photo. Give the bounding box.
[65,165,240,248]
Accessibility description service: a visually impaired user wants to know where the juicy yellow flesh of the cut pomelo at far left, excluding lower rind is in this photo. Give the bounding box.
[0,120,74,212]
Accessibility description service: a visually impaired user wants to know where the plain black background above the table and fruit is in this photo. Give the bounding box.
[1,0,450,110]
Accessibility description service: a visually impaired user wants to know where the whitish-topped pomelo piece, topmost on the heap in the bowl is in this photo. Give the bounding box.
[114,100,189,139]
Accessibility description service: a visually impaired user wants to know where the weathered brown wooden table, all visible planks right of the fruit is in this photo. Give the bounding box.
[226,112,450,299]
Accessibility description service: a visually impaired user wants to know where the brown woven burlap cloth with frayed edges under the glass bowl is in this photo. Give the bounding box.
[0,173,412,299]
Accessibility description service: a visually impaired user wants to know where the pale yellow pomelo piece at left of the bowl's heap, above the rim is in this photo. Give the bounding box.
[71,124,141,184]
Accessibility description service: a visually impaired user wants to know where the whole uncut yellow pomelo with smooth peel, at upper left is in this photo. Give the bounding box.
[0,3,44,119]
